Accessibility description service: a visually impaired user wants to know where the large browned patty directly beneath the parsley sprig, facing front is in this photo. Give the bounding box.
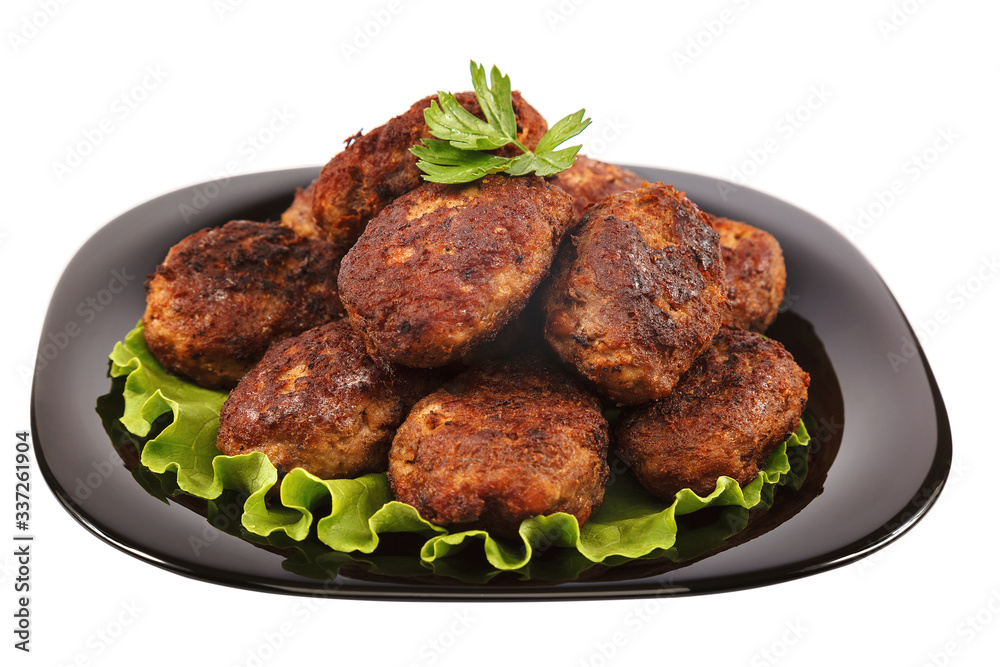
[340,175,572,368]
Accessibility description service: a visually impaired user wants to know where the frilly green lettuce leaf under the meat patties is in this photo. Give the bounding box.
[106,324,809,578]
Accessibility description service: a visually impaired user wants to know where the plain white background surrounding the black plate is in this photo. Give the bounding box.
[0,0,1000,667]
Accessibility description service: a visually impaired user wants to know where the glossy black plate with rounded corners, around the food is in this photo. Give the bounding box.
[32,168,951,599]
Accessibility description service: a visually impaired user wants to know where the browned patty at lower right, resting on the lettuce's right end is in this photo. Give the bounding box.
[615,328,809,502]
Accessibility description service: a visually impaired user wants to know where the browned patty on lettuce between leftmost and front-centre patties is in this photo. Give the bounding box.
[217,320,435,479]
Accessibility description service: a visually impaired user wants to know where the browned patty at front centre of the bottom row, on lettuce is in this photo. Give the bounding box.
[389,359,608,536]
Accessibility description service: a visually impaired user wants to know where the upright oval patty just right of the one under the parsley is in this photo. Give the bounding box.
[542,183,726,405]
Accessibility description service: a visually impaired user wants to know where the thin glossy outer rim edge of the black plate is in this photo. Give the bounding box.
[31,167,952,600]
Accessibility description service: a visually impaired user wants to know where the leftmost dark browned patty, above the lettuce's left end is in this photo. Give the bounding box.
[142,220,344,389]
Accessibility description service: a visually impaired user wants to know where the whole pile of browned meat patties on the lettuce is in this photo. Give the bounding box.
[143,92,809,536]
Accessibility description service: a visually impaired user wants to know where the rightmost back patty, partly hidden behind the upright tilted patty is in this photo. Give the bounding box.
[708,214,785,331]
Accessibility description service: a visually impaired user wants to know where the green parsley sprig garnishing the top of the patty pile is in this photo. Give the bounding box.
[410,61,590,183]
